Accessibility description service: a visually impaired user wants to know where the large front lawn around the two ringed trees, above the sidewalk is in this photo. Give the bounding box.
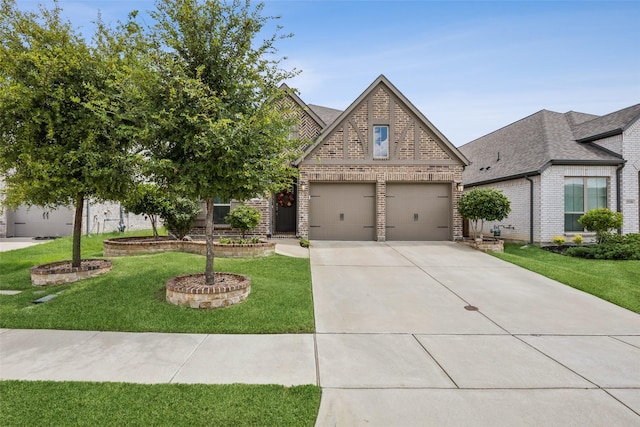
[0,231,314,334]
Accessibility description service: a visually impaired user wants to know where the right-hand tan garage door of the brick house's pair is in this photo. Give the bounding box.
[386,184,451,240]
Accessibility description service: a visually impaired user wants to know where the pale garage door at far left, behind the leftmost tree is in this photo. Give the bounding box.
[10,206,73,237]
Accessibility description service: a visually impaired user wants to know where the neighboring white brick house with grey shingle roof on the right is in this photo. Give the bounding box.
[459,104,640,244]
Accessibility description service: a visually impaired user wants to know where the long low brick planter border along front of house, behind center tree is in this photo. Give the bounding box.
[103,237,276,258]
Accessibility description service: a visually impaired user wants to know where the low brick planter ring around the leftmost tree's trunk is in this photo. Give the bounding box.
[29,259,113,286]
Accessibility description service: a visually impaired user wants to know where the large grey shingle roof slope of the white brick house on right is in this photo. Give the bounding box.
[460,110,624,185]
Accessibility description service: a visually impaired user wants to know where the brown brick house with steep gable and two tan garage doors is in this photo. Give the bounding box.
[284,75,468,241]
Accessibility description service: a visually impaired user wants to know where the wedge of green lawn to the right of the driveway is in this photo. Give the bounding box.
[493,243,640,313]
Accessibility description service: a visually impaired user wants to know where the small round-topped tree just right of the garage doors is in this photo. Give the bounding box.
[458,187,511,238]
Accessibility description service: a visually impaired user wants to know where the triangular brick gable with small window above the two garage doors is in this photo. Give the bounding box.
[298,75,468,165]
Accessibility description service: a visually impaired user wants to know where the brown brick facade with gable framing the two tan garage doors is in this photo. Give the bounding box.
[297,78,465,241]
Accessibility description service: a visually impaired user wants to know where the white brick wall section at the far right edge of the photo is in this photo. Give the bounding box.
[621,120,640,234]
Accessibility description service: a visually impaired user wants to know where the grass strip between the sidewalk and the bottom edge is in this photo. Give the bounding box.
[0,381,321,427]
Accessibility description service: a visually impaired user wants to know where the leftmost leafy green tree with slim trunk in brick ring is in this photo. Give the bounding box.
[0,0,142,267]
